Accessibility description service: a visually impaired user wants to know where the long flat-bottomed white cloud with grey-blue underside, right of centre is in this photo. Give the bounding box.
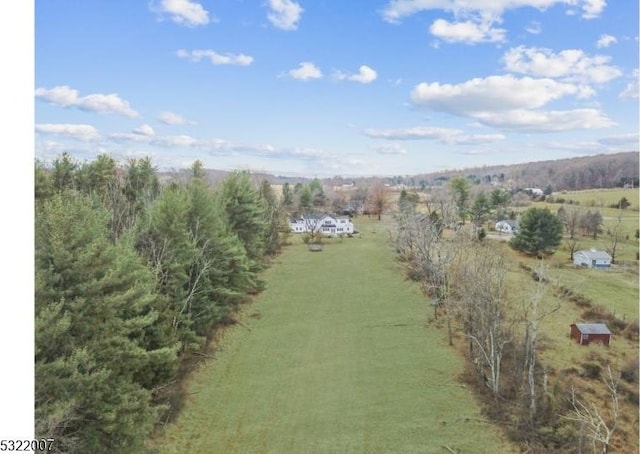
[411,75,592,115]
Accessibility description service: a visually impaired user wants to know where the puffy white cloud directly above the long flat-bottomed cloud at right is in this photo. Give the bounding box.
[503,46,622,83]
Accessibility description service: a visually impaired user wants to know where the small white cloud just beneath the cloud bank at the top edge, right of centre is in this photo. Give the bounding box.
[429,19,506,44]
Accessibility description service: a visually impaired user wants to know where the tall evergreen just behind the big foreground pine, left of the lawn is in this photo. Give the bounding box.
[137,178,260,349]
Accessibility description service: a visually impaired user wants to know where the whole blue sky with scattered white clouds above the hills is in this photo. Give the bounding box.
[34,0,639,177]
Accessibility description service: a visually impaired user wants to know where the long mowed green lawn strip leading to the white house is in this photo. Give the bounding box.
[153,218,516,453]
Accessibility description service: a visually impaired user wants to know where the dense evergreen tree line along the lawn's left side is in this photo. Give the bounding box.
[35,154,283,453]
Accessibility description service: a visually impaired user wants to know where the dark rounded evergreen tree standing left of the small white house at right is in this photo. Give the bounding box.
[510,208,562,258]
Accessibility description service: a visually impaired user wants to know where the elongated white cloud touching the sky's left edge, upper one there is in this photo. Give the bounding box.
[36,85,140,118]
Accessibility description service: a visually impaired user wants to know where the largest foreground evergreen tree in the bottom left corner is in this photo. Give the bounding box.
[35,191,177,453]
